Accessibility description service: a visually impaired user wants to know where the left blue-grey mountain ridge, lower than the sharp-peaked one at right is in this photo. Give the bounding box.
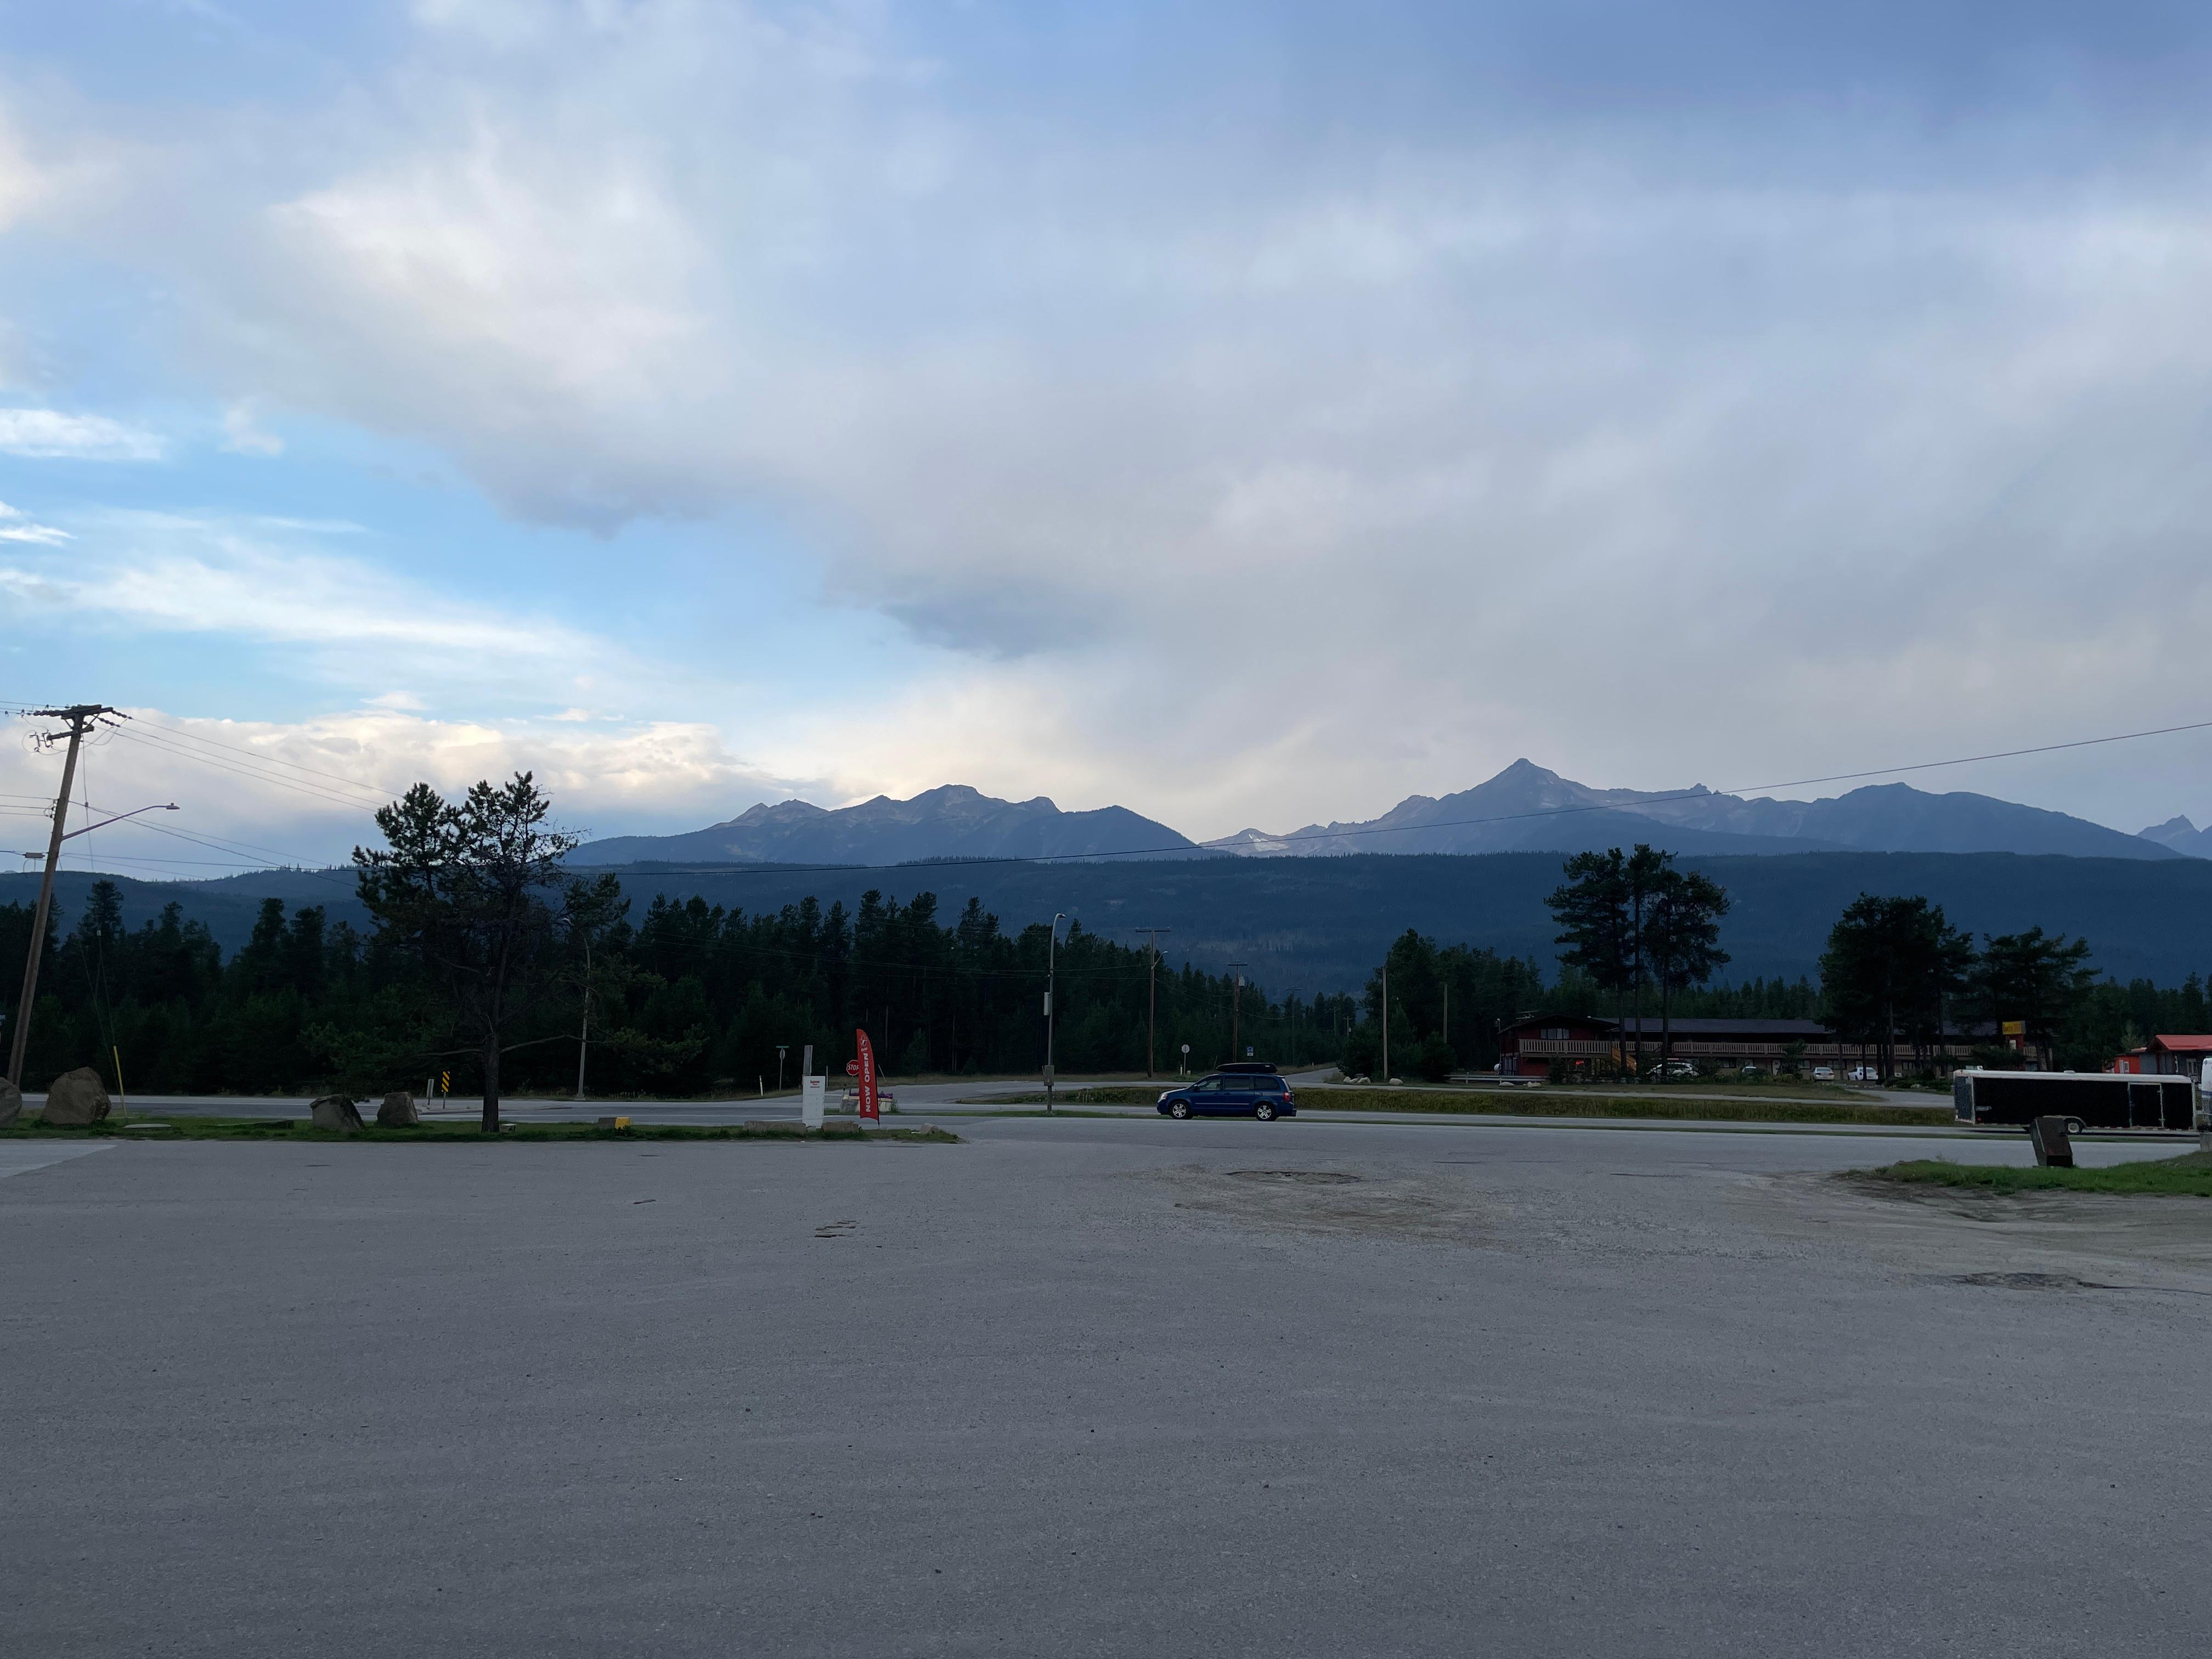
[571,783,1203,865]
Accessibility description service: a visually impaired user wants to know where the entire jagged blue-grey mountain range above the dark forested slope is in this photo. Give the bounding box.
[575,761,2212,865]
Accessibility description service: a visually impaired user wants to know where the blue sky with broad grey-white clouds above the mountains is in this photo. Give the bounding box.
[0,0,2212,874]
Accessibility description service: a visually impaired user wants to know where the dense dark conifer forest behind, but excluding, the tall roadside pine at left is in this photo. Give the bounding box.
[0,883,1356,1095]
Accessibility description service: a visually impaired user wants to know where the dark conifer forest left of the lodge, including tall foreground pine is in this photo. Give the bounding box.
[0,774,1358,1121]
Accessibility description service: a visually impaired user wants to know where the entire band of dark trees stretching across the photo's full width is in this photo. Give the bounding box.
[0,774,2208,1121]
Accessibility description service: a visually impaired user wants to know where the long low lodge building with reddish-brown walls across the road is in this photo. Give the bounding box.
[1498,1013,1989,1077]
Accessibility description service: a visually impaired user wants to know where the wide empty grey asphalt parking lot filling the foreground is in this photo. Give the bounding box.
[0,1119,2212,1655]
